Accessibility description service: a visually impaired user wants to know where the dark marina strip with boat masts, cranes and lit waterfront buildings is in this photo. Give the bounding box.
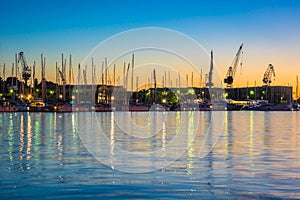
[0,50,299,112]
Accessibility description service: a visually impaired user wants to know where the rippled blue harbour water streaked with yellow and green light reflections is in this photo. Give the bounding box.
[0,112,300,199]
